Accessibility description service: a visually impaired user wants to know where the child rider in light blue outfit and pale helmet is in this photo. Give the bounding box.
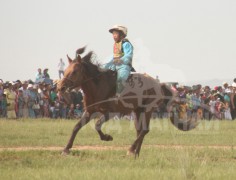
[105,25,134,96]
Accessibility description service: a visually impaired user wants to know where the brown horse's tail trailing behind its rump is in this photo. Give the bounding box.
[161,84,199,131]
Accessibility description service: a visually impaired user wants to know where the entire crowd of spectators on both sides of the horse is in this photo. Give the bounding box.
[0,73,236,120]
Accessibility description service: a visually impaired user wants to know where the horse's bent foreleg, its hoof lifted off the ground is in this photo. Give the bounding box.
[95,113,113,141]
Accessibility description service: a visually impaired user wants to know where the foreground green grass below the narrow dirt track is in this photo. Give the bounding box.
[0,148,236,180]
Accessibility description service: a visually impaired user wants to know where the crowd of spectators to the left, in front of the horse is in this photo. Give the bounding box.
[0,78,83,119]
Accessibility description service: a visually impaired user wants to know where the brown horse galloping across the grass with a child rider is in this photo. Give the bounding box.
[58,48,199,157]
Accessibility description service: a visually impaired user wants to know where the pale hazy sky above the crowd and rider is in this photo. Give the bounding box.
[0,0,236,84]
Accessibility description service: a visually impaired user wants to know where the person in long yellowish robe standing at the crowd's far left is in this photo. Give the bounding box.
[4,82,16,119]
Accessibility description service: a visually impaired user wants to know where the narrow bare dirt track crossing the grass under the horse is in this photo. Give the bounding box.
[0,144,236,151]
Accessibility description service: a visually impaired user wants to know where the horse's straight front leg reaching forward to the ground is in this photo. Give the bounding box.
[62,112,91,155]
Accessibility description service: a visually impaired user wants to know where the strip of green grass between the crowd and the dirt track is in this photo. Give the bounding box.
[0,119,236,147]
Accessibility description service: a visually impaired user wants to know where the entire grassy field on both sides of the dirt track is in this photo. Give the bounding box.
[0,119,236,180]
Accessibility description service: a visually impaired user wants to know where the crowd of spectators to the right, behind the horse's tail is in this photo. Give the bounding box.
[158,78,236,120]
